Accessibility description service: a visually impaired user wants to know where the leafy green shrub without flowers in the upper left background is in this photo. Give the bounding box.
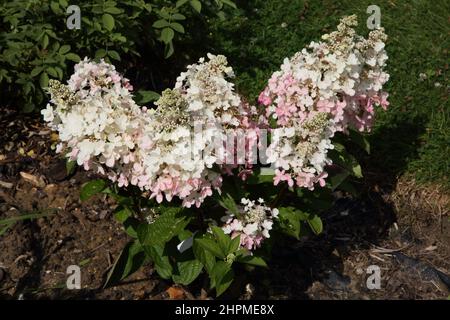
[0,0,235,112]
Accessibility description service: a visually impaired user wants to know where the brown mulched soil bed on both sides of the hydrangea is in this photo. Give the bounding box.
[0,111,450,299]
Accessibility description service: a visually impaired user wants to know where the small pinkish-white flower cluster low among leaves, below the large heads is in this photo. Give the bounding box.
[221,198,279,250]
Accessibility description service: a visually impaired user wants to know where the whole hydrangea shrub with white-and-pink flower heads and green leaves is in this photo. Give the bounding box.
[42,16,389,295]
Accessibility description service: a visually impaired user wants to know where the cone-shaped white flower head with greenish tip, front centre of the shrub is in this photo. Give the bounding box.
[131,89,222,207]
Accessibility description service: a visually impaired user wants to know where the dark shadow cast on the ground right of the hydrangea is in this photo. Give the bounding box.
[246,117,424,299]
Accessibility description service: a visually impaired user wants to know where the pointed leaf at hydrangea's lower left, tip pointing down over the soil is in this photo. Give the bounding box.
[103,241,145,288]
